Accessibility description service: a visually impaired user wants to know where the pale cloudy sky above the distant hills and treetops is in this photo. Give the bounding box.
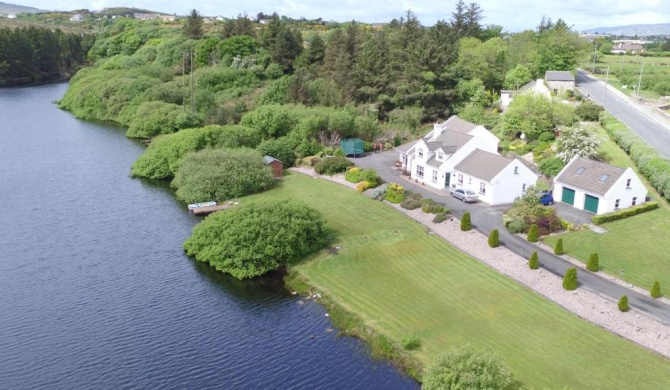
[11,0,670,32]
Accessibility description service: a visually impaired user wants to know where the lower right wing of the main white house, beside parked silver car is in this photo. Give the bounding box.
[451,149,537,205]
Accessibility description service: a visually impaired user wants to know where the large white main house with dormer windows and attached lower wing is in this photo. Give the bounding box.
[399,115,538,204]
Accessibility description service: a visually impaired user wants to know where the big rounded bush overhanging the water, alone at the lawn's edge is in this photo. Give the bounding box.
[184,199,328,279]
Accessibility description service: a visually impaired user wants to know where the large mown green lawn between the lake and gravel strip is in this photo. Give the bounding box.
[245,174,670,389]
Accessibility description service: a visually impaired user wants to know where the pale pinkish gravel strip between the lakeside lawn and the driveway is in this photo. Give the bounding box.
[291,168,670,357]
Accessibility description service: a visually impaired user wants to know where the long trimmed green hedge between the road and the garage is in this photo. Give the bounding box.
[600,113,670,200]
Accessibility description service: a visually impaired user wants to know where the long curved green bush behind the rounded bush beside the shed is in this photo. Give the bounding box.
[131,125,260,179]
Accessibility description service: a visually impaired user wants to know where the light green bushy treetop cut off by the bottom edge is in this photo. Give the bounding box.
[421,346,512,390]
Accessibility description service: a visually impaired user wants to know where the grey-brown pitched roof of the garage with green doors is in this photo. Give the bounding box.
[554,156,626,195]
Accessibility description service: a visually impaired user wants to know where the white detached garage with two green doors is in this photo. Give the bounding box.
[553,156,647,214]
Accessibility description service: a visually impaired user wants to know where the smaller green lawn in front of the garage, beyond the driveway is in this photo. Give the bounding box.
[544,209,670,295]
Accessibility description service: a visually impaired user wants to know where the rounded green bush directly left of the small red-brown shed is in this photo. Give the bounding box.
[172,149,274,203]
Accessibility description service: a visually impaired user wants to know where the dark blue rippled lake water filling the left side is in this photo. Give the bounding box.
[0,84,418,389]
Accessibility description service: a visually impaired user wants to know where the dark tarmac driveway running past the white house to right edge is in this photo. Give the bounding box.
[353,151,670,321]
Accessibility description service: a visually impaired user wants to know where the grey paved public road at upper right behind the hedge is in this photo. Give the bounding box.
[576,69,670,158]
